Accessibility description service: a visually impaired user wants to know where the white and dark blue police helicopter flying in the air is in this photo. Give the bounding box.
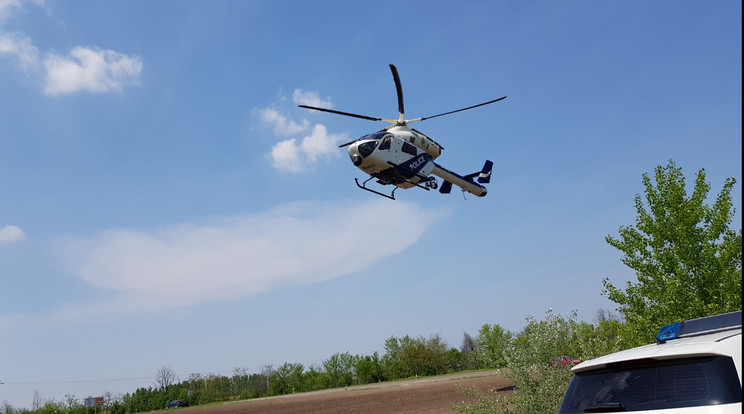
[298,64,506,200]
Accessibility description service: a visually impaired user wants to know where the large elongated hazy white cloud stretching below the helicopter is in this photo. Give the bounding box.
[45,200,439,324]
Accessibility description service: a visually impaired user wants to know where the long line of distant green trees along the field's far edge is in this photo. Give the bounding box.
[0,312,615,414]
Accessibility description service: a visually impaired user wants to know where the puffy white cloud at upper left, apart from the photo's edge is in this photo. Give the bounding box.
[44,46,142,95]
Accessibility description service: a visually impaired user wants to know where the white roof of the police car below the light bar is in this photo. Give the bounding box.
[572,327,741,373]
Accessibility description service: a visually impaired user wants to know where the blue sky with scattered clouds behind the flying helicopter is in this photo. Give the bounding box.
[0,0,742,407]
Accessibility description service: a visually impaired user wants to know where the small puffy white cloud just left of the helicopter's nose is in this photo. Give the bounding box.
[271,124,347,173]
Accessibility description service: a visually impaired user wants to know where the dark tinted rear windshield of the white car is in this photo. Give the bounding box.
[559,356,741,413]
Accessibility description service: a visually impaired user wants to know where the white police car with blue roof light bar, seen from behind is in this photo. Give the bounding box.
[559,311,742,414]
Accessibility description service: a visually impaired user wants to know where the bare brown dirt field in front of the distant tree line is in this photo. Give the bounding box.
[178,371,513,414]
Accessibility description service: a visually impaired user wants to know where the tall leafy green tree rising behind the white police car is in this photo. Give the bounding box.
[603,160,742,346]
